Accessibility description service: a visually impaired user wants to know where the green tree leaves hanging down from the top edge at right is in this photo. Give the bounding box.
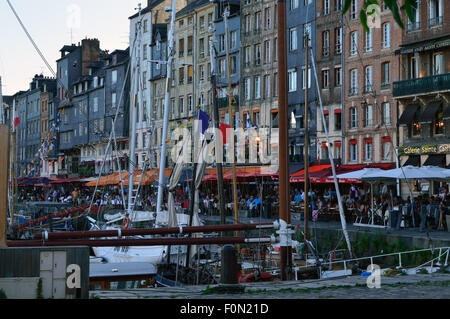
[342,0,417,32]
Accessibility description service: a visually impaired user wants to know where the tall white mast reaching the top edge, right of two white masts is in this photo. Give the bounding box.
[156,0,176,213]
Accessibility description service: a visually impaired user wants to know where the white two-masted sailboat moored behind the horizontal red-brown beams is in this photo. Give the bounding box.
[93,0,202,265]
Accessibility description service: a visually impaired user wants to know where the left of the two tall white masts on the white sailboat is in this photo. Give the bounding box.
[127,3,142,214]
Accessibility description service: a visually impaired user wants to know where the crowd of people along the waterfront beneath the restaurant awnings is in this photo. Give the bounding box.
[18,180,450,232]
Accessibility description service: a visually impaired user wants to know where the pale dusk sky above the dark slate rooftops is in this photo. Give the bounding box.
[0,0,140,95]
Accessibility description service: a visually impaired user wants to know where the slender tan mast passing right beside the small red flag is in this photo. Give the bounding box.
[223,8,239,228]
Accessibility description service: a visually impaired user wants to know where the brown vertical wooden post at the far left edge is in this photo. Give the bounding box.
[0,125,9,248]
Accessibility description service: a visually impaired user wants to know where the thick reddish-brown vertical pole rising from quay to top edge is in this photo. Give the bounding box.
[277,0,292,280]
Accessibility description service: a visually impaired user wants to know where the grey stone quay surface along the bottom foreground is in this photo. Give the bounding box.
[90,273,450,300]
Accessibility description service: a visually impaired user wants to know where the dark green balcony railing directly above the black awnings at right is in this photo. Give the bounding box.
[393,73,450,97]
